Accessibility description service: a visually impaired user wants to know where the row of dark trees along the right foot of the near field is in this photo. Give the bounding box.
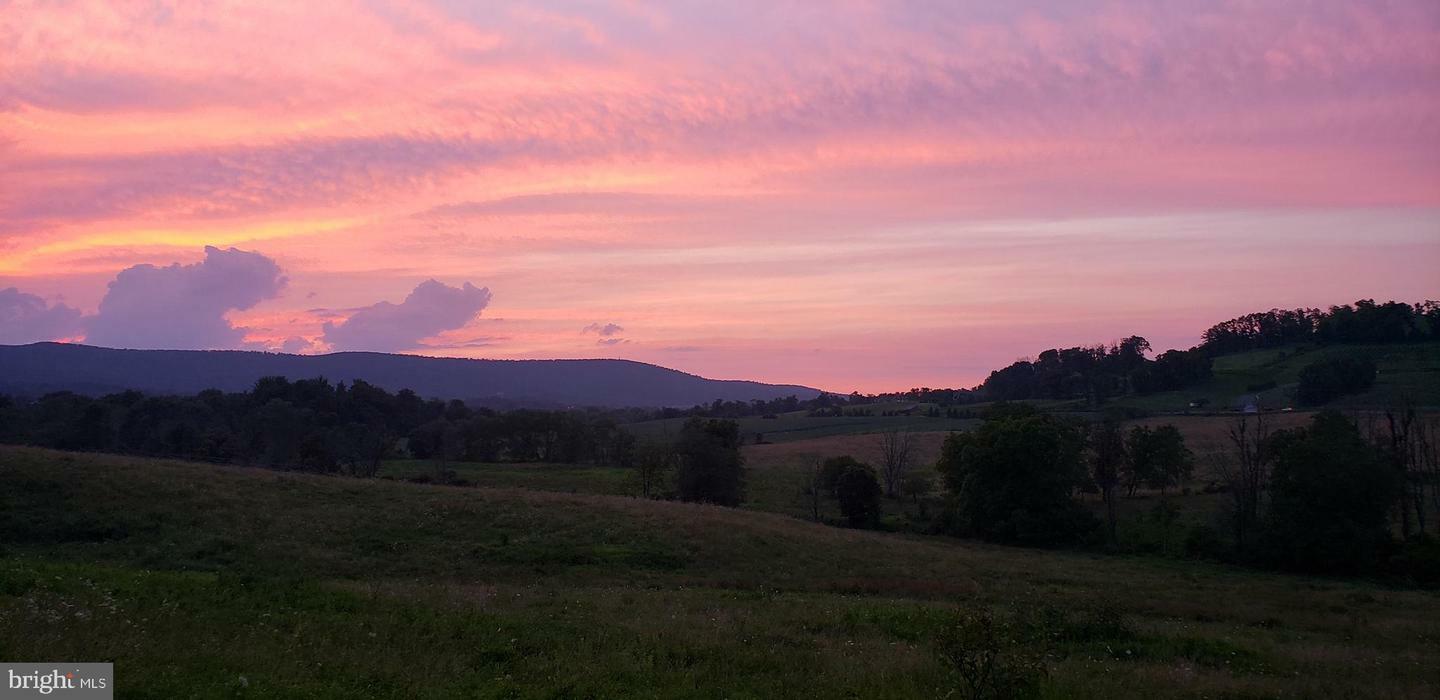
[936,405,1440,585]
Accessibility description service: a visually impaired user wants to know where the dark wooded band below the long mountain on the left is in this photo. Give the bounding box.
[0,377,634,475]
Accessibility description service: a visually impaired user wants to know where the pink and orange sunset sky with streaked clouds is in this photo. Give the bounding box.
[0,0,1440,392]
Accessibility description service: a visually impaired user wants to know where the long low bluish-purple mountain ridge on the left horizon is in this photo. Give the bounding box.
[0,343,819,408]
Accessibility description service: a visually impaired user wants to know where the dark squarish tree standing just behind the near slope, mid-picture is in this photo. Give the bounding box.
[675,418,744,506]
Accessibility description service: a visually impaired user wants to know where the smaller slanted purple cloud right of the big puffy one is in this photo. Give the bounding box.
[321,279,490,353]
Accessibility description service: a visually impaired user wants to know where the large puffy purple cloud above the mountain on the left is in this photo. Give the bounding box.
[85,246,287,350]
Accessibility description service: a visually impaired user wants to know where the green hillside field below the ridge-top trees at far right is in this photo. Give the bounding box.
[1112,343,1440,412]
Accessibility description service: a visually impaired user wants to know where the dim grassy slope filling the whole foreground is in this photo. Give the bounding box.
[0,445,1440,699]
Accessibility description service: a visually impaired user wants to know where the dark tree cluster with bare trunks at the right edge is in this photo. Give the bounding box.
[1223,409,1440,583]
